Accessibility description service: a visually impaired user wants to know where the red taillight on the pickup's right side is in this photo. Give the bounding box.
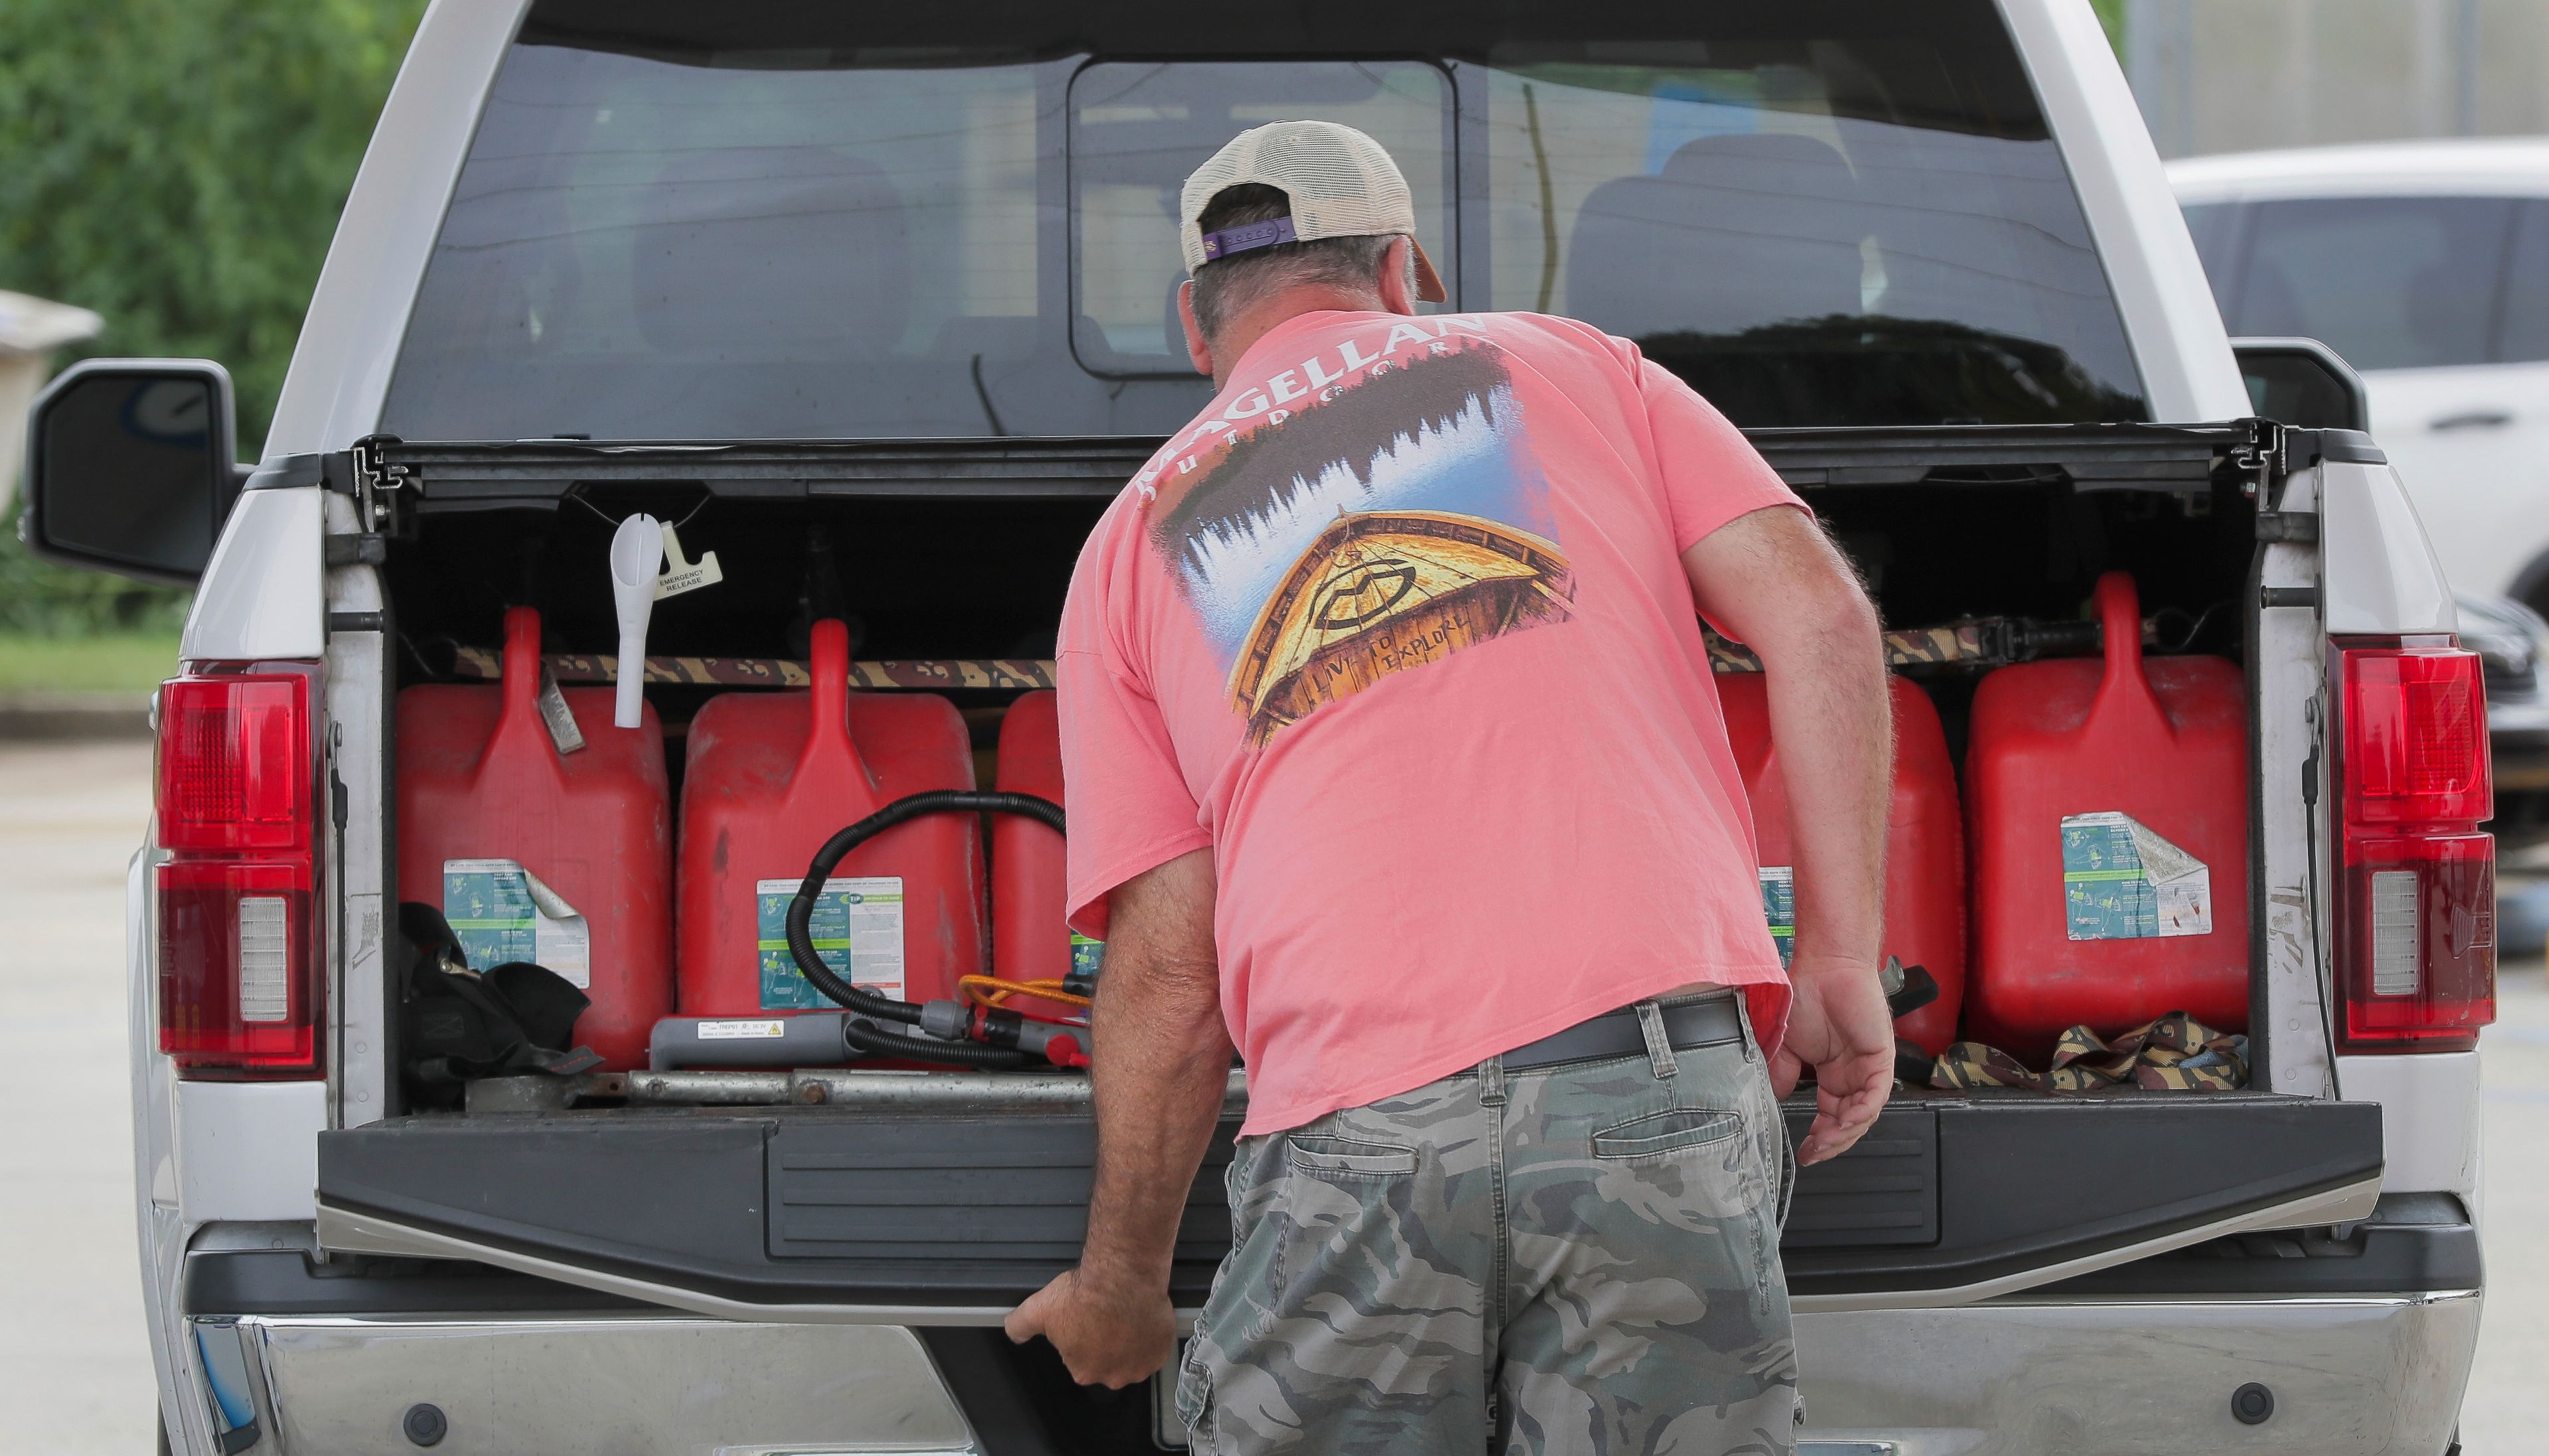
[2337,645,2495,1053]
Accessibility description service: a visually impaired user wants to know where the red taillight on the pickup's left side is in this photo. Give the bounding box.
[155,663,321,1078]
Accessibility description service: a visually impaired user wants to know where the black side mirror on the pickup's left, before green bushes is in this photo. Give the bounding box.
[18,360,240,587]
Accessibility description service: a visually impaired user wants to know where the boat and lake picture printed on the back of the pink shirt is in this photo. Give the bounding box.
[1150,329,1575,745]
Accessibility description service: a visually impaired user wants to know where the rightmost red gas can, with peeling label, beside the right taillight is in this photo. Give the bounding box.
[1966,571,2248,1056]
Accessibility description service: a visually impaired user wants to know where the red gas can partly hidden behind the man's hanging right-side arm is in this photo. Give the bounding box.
[1718,673,1966,1056]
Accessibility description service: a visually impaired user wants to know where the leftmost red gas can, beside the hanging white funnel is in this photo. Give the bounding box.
[398,607,673,1068]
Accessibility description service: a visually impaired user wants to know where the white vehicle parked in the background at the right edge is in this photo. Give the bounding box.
[2169,137,2549,609]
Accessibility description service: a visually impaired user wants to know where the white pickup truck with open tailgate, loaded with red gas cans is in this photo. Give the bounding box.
[25,0,2495,1456]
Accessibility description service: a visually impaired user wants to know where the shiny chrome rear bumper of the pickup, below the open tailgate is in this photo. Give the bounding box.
[175,1290,2480,1456]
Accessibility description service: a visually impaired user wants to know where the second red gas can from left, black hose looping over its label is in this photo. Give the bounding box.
[678,622,981,1015]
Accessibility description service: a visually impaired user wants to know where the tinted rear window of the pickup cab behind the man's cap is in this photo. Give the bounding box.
[382,0,2146,439]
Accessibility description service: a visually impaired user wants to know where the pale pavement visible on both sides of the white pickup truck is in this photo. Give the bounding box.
[0,739,2549,1456]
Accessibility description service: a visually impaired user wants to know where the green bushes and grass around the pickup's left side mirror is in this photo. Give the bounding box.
[0,0,423,632]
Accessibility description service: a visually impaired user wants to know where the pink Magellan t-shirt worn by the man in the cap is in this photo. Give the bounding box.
[1058,311,1800,1135]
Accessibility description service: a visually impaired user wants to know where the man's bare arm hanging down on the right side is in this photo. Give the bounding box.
[1682,505,1894,1163]
